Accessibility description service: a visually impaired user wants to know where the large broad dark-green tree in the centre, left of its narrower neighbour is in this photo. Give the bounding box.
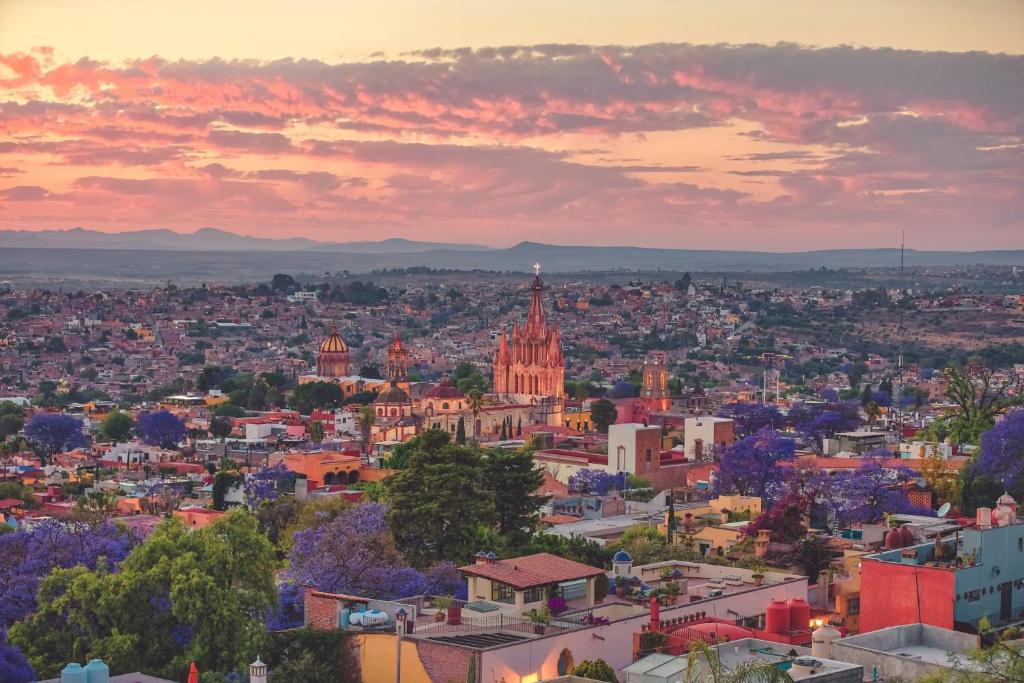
[384,445,495,568]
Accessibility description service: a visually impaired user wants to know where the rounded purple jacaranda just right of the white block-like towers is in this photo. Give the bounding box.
[714,428,797,505]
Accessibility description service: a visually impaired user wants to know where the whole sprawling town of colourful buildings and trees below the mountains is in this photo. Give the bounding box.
[0,264,1024,683]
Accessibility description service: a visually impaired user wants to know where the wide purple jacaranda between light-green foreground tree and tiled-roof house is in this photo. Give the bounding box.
[288,503,465,600]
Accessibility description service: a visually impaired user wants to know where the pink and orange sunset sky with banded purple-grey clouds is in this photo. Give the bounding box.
[0,0,1024,251]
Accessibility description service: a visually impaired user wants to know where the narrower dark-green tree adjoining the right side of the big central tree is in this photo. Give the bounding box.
[483,449,548,545]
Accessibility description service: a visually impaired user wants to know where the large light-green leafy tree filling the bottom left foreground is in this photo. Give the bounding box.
[10,511,275,680]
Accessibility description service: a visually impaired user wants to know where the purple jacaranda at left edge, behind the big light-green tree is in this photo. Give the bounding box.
[0,522,138,629]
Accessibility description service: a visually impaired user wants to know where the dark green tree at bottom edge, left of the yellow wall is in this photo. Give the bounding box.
[266,628,361,683]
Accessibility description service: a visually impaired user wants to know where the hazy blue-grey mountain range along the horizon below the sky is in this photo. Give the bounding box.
[0,228,1024,282]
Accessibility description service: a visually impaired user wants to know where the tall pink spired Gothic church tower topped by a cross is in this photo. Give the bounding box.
[494,264,565,414]
